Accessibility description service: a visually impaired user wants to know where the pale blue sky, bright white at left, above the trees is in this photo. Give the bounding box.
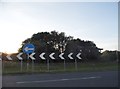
[0,2,118,53]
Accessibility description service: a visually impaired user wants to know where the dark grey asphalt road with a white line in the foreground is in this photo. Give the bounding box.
[2,71,118,87]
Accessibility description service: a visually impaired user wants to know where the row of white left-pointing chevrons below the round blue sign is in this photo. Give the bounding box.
[6,52,82,60]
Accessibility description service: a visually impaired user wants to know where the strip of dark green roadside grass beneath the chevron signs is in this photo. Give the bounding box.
[2,61,118,75]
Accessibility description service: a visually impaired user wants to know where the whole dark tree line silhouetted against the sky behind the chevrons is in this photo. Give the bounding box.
[1,31,117,62]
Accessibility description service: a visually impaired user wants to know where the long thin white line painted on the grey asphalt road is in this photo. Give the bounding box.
[16,76,101,84]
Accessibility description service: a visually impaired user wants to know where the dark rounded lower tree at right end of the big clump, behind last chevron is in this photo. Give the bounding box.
[66,38,101,61]
